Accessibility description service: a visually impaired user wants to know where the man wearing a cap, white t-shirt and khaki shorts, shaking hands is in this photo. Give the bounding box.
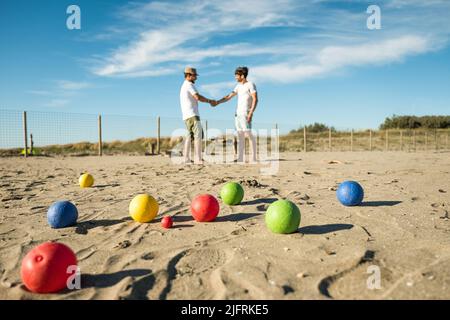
[180,67,216,164]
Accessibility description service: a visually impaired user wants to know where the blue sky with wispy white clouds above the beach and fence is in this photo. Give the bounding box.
[0,0,450,129]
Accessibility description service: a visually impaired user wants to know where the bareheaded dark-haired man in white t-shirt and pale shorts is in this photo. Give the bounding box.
[216,67,258,162]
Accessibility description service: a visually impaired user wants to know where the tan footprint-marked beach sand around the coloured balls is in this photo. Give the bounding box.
[0,152,450,299]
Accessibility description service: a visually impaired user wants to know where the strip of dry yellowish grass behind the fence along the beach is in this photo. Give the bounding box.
[0,129,450,156]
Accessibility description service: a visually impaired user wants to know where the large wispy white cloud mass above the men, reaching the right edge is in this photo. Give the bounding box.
[93,0,450,82]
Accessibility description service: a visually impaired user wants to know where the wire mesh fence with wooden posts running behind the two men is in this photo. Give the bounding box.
[0,110,450,156]
